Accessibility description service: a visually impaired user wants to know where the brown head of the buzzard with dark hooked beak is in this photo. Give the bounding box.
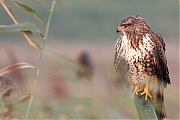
[116,15,150,33]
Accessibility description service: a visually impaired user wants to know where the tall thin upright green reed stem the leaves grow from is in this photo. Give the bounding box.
[26,0,56,119]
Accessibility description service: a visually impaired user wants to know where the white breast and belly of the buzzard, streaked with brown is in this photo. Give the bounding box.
[116,35,154,84]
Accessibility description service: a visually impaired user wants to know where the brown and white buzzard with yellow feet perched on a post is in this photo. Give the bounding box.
[114,15,170,119]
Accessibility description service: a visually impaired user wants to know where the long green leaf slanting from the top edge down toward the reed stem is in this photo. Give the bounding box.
[13,0,47,24]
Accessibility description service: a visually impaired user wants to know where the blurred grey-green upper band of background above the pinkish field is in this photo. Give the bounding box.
[0,0,179,41]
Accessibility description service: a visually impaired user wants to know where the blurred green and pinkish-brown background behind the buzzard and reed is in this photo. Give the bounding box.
[0,0,180,119]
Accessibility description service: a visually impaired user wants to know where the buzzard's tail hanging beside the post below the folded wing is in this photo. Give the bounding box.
[155,85,167,120]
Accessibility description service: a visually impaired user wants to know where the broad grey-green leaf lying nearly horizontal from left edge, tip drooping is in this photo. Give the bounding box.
[0,22,44,38]
